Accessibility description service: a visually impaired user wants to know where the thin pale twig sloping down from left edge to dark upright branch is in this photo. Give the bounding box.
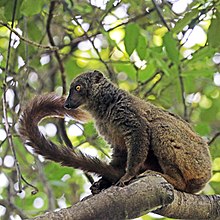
[0,21,59,51]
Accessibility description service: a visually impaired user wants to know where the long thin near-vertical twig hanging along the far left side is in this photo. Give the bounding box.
[2,0,22,192]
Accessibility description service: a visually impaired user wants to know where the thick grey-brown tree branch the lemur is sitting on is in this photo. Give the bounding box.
[32,173,220,220]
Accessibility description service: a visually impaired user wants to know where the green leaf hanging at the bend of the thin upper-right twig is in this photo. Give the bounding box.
[163,32,179,64]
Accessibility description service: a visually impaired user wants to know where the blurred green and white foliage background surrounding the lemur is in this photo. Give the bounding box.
[0,0,220,220]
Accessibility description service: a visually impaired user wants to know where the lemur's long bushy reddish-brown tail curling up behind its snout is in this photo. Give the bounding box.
[19,93,120,182]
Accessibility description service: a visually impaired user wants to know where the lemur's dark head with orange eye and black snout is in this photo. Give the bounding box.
[64,70,104,109]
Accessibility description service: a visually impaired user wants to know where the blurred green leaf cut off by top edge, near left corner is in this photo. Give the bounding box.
[20,0,44,17]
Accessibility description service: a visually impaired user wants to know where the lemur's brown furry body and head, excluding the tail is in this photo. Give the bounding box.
[65,71,211,192]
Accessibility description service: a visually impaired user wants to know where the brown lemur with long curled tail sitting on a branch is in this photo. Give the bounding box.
[19,71,211,193]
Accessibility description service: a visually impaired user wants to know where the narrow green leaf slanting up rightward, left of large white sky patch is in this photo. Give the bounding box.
[172,8,199,33]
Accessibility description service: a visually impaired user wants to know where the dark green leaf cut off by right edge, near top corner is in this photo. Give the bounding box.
[208,13,220,48]
